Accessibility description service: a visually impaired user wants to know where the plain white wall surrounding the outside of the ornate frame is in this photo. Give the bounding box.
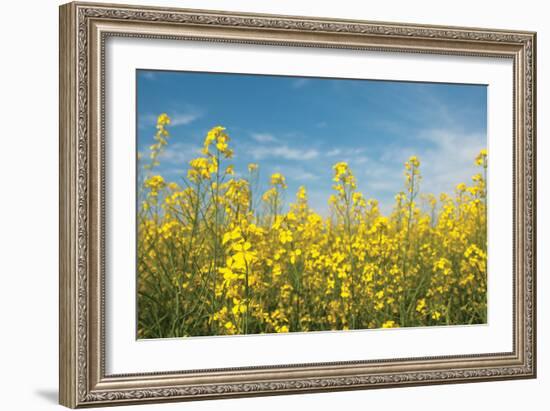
[0,0,550,411]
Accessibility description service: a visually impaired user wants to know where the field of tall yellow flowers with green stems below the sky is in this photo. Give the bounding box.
[137,114,487,338]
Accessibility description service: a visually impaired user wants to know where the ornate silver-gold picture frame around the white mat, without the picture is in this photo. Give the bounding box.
[60,3,536,408]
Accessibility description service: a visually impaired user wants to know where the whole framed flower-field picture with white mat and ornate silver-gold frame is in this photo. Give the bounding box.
[60,3,536,408]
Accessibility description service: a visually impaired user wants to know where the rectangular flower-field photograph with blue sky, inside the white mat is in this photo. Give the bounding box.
[136,70,488,338]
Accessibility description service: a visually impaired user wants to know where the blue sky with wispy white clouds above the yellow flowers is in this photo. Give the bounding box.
[137,70,487,215]
